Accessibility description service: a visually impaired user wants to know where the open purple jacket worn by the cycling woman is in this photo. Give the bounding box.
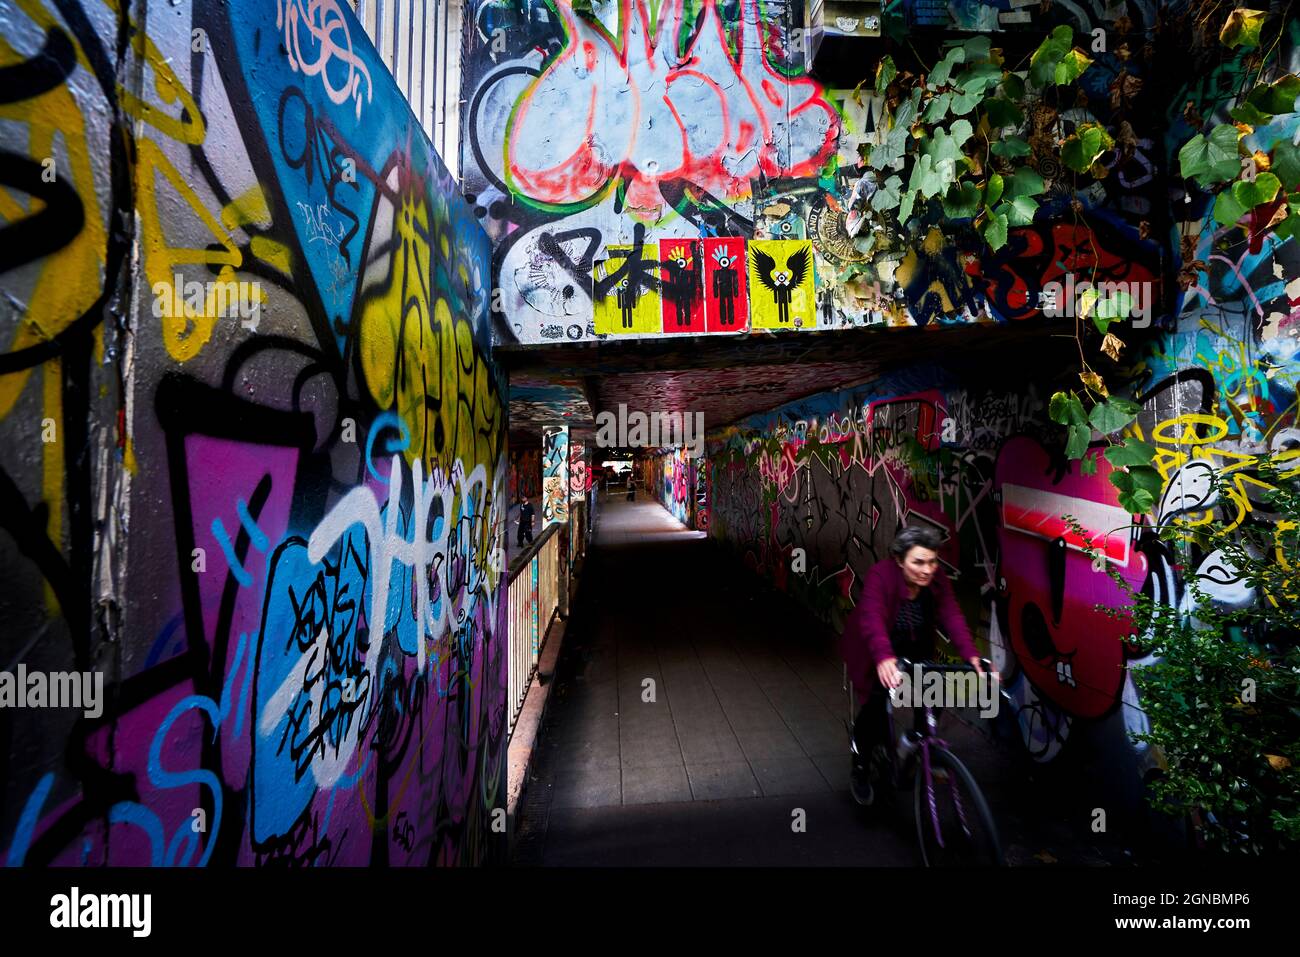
[840,558,979,697]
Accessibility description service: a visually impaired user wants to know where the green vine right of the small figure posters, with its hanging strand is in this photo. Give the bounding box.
[848,26,1161,512]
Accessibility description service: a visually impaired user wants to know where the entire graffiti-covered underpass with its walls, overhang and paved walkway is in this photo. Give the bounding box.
[0,0,1300,867]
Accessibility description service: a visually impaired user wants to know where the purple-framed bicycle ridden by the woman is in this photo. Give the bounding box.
[844,658,1010,867]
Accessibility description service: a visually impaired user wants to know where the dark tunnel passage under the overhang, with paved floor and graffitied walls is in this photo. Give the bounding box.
[504,321,1196,865]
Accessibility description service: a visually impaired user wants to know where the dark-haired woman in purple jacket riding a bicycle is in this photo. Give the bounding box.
[842,527,984,804]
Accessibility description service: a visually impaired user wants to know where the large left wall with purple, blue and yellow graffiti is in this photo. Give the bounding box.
[0,0,507,865]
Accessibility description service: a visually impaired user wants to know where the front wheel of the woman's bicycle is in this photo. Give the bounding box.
[914,748,1004,867]
